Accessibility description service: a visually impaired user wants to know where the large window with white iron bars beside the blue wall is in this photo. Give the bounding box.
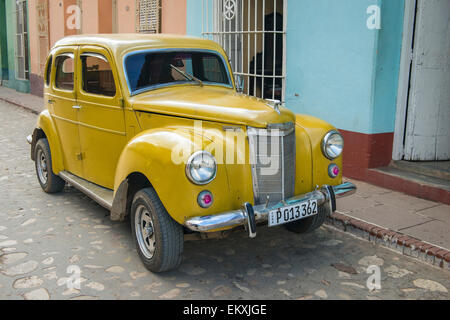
[202,0,288,101]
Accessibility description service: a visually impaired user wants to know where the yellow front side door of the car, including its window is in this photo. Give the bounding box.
[77,46,127,189]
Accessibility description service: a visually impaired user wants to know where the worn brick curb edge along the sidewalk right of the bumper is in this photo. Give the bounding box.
[325,212,450,270]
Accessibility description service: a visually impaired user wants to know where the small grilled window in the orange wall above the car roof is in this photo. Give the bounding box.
[136,0,161,33]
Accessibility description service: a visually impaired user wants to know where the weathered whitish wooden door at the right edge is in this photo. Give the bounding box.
[393,0,450,162]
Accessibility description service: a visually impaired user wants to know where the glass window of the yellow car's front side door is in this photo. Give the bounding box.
[81,53,116,97]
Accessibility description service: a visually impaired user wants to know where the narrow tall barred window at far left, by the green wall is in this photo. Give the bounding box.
[15,0,30,80]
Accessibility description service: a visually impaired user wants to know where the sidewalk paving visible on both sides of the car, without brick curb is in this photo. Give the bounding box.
[0,86,450,259]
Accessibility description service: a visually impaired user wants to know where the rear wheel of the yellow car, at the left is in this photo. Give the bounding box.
[34,138,66,193]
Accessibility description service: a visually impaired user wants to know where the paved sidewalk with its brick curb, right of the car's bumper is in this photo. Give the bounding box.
[334,181,450,270]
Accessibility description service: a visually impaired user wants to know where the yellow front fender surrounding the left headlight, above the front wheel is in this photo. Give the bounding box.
[111,127,233,224]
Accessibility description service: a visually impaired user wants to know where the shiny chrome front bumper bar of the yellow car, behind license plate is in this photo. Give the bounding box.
[184,182,356,232]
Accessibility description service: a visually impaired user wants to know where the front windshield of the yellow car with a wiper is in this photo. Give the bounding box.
[125,50,231,93]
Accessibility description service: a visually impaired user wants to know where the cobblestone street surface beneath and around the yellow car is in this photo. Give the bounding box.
[0,102,450,300]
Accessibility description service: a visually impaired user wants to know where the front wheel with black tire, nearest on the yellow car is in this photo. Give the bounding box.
[130,188,184,273]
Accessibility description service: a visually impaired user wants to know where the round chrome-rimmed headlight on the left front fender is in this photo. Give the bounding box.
[186,151,217,185]
